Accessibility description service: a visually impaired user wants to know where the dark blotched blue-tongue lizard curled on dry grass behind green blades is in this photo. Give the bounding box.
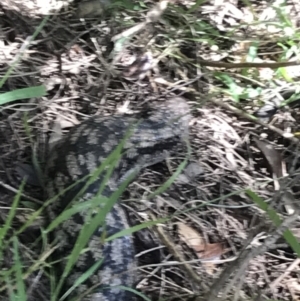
[45,97,190,301]
